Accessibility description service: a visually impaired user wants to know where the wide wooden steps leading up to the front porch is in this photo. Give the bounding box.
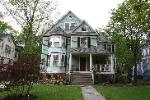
[71,73,93,85]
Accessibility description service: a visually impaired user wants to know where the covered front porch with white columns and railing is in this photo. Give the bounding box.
[69,53,115,74]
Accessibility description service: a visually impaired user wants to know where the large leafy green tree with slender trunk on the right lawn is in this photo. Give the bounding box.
[106,0,150,84]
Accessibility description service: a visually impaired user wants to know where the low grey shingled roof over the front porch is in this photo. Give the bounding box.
[70,47,110,54]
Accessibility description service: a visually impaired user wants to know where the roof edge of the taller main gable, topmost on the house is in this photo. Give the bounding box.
[44,11,81,34]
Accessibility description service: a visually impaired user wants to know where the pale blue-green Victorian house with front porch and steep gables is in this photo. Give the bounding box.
[41,11,115,74]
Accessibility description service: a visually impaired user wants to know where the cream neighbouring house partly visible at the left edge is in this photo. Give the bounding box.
[0,33,15,64]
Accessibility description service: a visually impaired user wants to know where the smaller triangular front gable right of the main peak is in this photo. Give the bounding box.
[72,21,95,33]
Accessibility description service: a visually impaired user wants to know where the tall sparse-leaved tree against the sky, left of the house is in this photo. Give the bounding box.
[0,0,56,45]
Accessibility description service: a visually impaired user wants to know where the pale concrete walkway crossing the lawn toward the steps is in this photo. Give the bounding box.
[81,86,106,100]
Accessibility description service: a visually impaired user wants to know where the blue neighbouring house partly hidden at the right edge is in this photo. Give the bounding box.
[137,43,150,80]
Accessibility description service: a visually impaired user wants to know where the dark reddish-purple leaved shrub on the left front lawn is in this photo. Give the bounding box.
[0,55,39,99]
